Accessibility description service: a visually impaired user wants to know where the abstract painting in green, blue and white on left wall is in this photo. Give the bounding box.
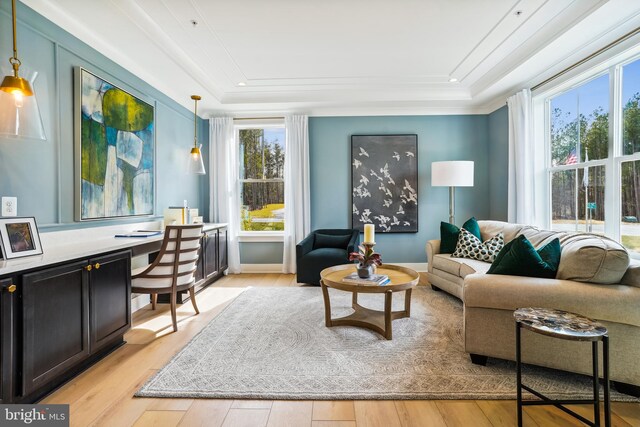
[75,67,155,221]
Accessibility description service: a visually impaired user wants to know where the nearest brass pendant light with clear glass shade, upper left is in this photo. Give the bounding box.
[0,0,47,140]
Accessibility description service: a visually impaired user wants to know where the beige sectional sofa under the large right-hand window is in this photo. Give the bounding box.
[426,221,640,396]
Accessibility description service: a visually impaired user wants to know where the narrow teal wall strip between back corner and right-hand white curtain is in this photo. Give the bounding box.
[489,105,509,221]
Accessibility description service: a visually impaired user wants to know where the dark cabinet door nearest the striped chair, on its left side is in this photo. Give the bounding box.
[89,251,131,353]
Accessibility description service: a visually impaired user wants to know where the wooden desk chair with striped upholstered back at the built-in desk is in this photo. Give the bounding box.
[131,224,202,332]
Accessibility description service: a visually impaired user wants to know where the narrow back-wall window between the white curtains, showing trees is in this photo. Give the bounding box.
[236,126,285,233]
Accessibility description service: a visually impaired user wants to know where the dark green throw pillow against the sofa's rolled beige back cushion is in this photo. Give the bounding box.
[487,234,561,279]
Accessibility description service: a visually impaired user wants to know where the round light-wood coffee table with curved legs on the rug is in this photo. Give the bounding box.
[320,264,420,340]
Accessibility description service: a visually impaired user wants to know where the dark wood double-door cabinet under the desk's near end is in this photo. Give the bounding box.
[20,251,131,400]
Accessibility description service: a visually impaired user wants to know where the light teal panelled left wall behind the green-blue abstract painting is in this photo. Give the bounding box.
[0,1,209,231]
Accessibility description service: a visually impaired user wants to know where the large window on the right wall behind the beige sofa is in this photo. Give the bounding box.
[544,58,640,257]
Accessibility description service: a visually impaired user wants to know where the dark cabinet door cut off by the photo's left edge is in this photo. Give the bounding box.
[0,278,15,404]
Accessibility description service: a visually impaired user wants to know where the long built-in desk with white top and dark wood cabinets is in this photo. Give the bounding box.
[0,223,227,403]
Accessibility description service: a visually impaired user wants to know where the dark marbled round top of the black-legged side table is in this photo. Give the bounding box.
[513,307,607,341]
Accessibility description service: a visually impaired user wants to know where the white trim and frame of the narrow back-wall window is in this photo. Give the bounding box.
[233,119,287,237]
